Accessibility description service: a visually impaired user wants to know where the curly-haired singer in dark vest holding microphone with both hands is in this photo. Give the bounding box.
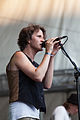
[6,24,60,120]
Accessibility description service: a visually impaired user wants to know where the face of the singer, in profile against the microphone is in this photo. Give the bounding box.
[30,30,44,51]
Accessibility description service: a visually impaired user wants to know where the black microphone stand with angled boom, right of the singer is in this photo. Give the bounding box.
[59,42,80,120]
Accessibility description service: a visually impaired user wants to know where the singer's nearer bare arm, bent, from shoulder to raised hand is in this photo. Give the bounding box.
[14,39,58,82]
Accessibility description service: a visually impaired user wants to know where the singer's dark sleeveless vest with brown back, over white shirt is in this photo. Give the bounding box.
[6,53,46,112]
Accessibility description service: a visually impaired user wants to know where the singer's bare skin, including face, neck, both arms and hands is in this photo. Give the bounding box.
[8,29,59,89]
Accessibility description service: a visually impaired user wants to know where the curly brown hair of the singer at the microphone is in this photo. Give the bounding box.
[17,24,46,51]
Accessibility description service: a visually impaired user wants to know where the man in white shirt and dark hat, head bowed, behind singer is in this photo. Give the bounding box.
[51,94,78,120]
